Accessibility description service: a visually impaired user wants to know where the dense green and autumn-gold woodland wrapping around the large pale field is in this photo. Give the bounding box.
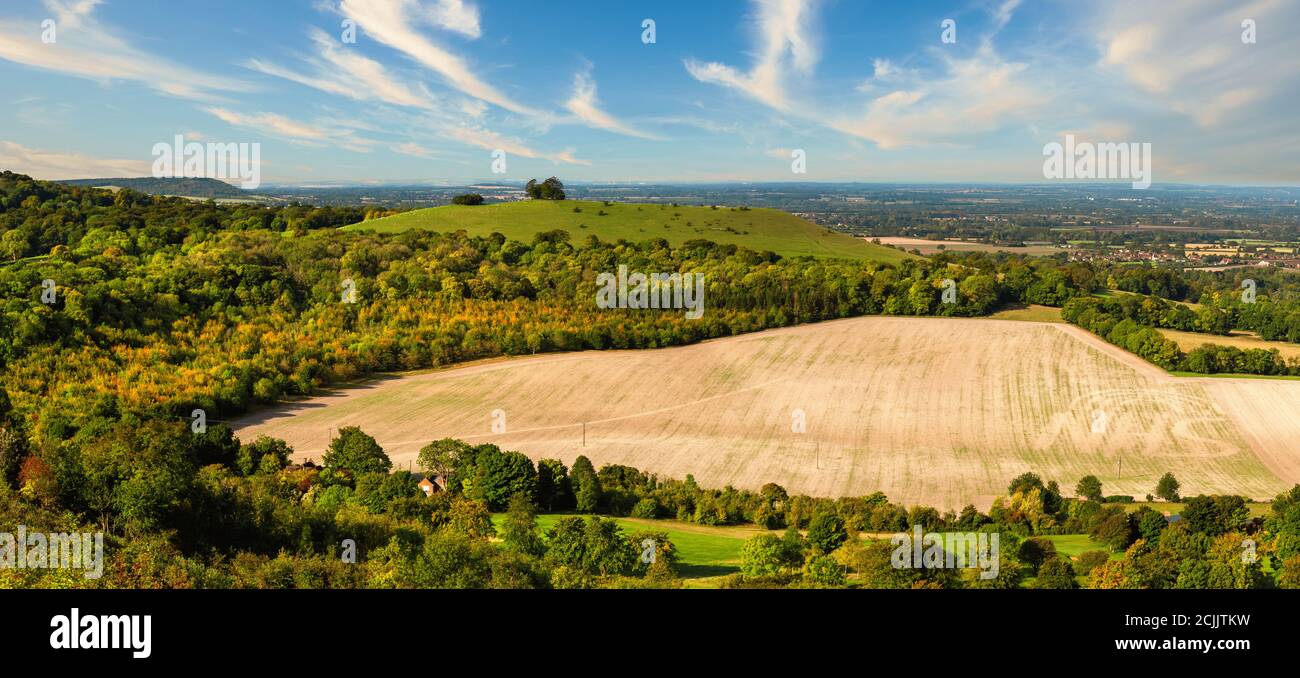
[0,173,1300,587]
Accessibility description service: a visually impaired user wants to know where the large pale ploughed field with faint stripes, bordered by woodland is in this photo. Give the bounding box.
[228,317,1300,509]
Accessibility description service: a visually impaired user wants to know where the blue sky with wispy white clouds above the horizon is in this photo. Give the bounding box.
[0,0,1300,184]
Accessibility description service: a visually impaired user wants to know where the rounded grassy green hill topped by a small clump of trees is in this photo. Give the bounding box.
[345,200,917,264]
